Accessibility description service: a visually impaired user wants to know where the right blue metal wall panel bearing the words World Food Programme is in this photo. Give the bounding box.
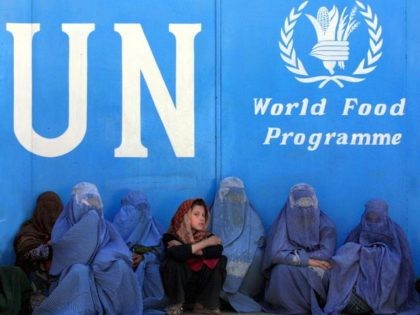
[221,0,420,272]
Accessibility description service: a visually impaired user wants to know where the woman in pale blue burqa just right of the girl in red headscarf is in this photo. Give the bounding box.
[211,177,264,312]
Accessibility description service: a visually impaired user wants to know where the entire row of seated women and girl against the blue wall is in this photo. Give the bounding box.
[0,177,420,315]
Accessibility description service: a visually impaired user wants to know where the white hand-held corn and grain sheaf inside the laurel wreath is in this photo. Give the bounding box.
[306,6,359,75]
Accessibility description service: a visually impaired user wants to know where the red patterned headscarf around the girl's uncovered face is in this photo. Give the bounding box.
[168,199,211,244]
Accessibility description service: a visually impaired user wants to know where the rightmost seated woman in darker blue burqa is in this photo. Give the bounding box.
[325,199,420,314]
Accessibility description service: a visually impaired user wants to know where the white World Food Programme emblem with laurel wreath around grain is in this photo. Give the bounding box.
[279,1,383,88]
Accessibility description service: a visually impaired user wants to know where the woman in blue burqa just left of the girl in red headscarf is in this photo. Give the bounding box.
[113,191,169,314]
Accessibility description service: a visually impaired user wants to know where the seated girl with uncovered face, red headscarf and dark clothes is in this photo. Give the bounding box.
[161,199,226,315]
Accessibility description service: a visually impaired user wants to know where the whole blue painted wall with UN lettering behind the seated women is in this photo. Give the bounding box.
[0,0,420,274]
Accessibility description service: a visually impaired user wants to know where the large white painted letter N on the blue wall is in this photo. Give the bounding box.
[114,23,201,157]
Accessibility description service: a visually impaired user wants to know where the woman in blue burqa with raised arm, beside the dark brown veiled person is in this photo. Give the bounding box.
[34,182,142,315]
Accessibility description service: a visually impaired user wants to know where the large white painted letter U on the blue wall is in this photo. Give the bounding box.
[6,23,95,157]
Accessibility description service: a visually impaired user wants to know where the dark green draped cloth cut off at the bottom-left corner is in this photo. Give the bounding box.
[0,266,33,315]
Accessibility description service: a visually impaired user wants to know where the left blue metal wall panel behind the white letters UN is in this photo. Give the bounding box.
[0,0,216,263]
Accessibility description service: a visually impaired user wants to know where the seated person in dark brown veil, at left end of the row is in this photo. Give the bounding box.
[14,191,63,308]
